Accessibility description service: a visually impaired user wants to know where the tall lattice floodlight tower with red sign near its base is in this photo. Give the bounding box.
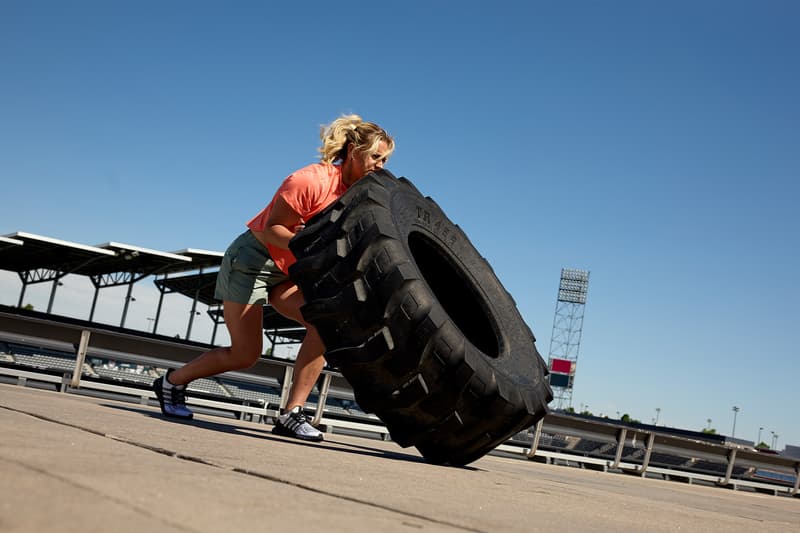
[548,268,589,409]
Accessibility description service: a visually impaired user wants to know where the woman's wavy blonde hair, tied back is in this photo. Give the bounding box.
[317,115,394,164]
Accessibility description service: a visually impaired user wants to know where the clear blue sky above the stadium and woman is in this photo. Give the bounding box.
[0,0,800,448]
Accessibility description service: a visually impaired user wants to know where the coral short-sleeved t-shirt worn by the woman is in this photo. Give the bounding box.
[247,163,347,274]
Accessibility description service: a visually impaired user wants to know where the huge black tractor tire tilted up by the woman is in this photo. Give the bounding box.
[289,170,552,465]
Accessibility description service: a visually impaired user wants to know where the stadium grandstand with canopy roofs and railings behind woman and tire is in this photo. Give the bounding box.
[0,233,800,495]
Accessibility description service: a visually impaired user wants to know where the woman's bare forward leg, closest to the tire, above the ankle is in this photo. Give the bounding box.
[269,281,325,410]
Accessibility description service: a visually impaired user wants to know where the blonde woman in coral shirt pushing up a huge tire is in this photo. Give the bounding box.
[153,115,394,441]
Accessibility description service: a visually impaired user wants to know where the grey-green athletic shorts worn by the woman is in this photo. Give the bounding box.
[214,229,289,305]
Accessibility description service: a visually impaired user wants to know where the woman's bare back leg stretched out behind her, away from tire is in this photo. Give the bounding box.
[169,301,264,385]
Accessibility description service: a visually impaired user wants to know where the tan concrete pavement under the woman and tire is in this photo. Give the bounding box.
[0,384,800,533]
